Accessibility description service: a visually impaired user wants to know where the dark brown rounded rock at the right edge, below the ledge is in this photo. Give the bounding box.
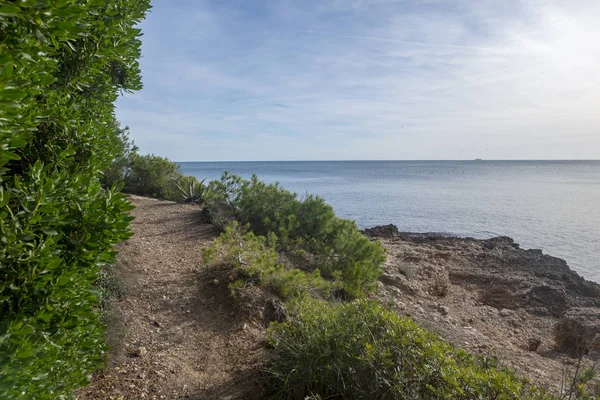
[554,308,600,357]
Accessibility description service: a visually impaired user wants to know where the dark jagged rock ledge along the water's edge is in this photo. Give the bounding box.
[365,225,600,317]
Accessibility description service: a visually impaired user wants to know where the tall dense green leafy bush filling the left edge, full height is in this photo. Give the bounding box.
[0,0,149,399]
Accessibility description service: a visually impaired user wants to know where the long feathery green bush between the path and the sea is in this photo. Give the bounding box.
[204,172,385,298]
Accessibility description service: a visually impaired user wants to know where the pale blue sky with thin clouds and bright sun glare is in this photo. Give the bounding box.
[117,0,600,161]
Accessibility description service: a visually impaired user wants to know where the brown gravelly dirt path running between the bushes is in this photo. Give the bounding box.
[79,196,263,400]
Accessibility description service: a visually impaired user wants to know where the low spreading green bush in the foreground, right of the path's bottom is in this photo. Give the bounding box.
[267,300,551,400]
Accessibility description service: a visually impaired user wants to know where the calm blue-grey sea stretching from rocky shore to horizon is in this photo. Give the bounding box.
[180,161,600,282]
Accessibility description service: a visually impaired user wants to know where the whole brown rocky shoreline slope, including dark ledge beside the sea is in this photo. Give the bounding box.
[364,225,600,390]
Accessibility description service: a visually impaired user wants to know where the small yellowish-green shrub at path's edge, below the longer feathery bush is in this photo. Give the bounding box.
[204,222,331,300]
